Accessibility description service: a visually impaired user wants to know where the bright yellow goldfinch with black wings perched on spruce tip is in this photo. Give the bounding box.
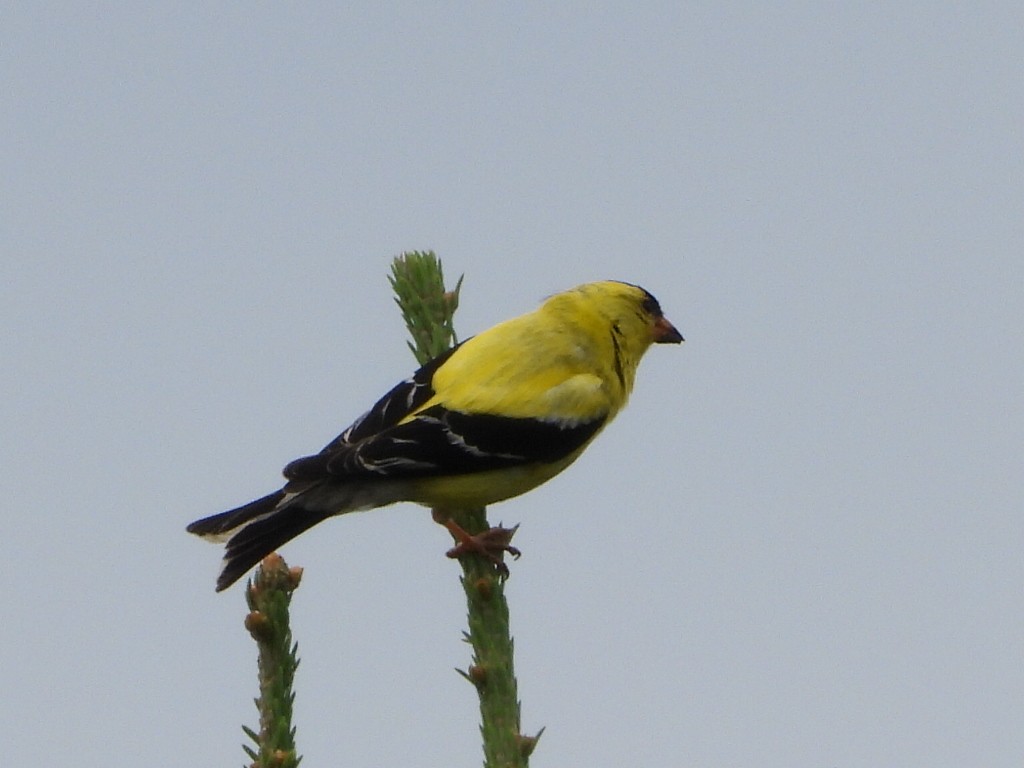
[188,281,683,592]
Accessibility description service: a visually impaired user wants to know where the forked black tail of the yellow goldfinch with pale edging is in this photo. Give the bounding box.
[187,490,330,592]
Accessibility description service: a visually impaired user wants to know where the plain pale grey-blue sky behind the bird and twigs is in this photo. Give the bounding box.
[0,2,1024,768]
